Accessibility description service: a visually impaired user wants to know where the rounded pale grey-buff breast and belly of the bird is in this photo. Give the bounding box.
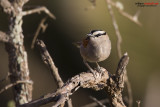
[80,37,111,62]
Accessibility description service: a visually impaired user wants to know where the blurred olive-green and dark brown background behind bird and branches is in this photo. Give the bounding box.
[0,0,160,107]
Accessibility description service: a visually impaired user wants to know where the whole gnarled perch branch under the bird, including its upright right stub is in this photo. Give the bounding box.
[19,54,129,107]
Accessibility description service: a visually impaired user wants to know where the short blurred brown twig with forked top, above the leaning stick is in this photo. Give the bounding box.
[31,17,48,49]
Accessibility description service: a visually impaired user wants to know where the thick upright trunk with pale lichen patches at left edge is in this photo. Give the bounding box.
[0,0,32,105]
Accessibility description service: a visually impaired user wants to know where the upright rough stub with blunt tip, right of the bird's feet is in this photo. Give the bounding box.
[106,53,129,107]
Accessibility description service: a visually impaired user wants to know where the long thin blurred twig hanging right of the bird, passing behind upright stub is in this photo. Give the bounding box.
[106,0,133,107]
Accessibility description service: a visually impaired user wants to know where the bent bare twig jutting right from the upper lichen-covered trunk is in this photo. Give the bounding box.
[22,6,56,19]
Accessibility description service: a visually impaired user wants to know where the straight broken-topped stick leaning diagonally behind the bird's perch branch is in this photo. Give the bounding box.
[36,40,72,107]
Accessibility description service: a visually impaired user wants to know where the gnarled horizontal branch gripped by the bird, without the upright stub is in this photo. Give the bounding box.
[19,68,109,107]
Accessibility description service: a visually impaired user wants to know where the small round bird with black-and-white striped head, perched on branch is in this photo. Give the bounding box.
[74,30,111,72]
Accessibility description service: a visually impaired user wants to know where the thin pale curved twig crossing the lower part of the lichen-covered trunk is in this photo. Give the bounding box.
[0,81,33,94]
